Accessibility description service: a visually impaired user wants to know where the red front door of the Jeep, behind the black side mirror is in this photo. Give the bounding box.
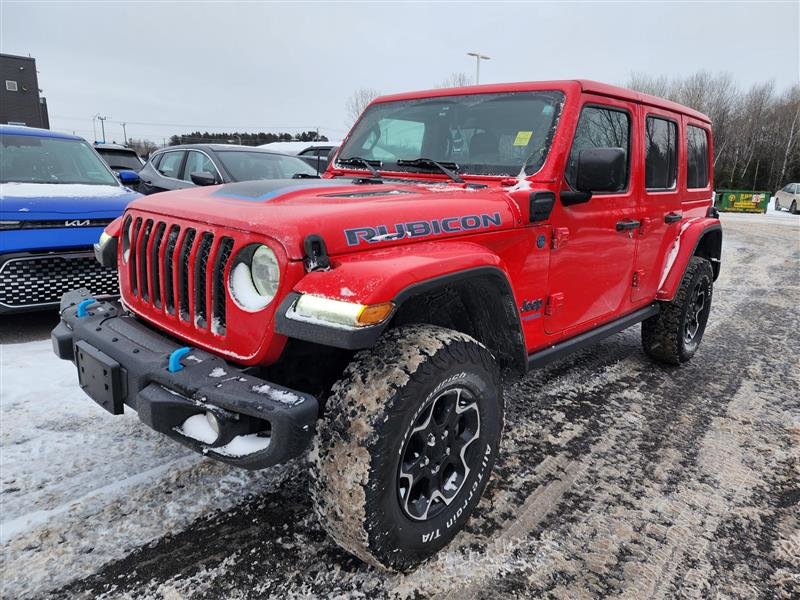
[545,95,639,333]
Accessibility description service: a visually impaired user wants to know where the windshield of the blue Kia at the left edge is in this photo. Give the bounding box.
[0,134,119,186]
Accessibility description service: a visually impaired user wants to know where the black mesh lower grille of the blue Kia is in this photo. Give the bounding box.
[0,252,119,308]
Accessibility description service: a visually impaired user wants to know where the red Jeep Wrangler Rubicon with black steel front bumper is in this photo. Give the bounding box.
[53,81,722,569]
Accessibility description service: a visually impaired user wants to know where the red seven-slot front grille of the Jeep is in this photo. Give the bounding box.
[126,217,233,335]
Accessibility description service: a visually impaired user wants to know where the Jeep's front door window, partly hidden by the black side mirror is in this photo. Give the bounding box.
[564,106,631,191]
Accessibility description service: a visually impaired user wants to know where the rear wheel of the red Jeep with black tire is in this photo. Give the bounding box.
[642,256,714,365]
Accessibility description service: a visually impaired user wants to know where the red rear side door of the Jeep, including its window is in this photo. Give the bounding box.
[631,106,686,303]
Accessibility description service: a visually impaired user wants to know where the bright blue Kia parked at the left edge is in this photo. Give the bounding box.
[0,125,140,313]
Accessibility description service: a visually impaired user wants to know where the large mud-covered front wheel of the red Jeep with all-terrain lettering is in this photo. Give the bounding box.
[310,325,503,571]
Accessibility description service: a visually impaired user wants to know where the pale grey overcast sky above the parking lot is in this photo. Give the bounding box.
[0,0,800,143]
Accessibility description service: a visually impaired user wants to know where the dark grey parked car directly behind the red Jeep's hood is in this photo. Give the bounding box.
[139,144,317,194]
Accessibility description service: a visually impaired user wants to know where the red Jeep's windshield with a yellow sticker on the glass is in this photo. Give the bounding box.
[337,91,564,177]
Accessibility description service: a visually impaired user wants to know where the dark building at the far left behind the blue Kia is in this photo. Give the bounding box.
[0,54,50,129]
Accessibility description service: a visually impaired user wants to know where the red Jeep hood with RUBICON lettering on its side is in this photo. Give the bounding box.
[130,179,517,260]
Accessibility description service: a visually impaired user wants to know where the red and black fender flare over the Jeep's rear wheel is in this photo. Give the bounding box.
[656,218,722,302]
